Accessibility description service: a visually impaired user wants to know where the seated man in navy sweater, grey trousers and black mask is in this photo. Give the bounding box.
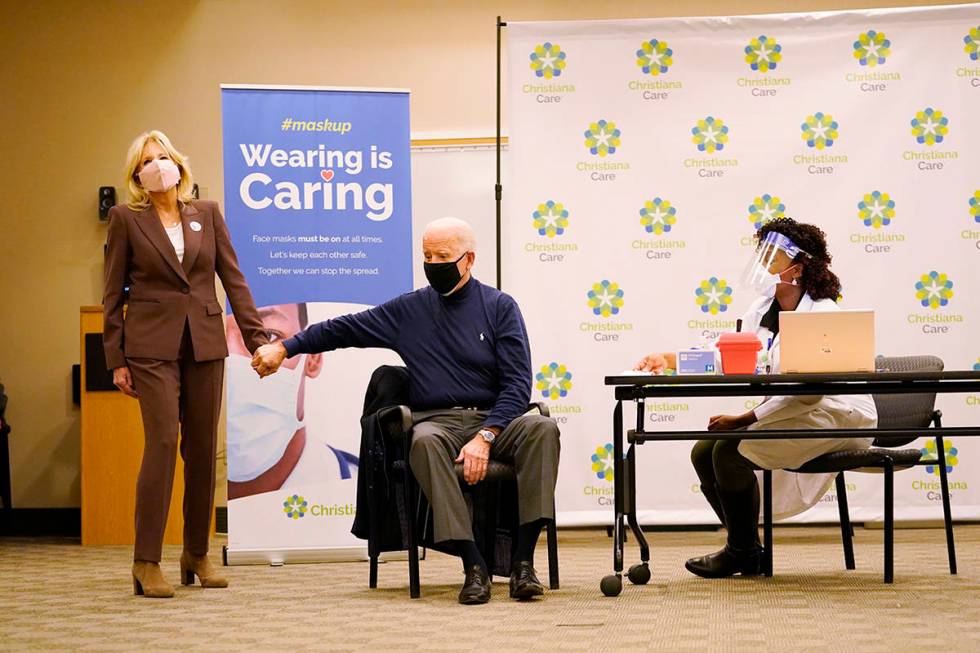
[252,218,560,604]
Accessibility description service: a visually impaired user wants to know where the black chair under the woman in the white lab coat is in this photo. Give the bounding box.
[762,356,956,583]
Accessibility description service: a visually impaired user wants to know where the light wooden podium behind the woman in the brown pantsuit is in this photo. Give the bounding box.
[79,306,214,545]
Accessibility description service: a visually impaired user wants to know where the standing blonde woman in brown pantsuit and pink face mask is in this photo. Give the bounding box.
[103,131,268,597]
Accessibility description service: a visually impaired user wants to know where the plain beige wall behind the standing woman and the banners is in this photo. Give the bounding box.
[0,0,964,507]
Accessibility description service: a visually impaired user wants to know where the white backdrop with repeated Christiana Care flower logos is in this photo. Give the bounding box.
[502,4,980,525]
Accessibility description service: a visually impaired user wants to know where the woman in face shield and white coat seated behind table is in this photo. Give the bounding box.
[636,218,878,578]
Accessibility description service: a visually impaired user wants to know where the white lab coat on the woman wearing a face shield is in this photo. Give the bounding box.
[738,293,878,519]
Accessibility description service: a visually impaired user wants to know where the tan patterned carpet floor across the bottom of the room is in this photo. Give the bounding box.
[0,525,980,653]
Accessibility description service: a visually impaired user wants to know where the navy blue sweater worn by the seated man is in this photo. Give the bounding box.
[283,278,531,429]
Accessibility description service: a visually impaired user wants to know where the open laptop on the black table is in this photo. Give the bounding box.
[779,310,875,372]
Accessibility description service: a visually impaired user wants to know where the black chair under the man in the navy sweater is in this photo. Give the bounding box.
[362,404,559,599]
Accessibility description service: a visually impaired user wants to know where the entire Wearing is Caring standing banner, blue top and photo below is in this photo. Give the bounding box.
[221,86,412,564]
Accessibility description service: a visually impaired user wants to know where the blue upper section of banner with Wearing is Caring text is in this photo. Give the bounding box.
[221,87,412,306]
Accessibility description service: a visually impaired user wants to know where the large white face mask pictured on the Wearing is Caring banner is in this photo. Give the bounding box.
[227,354,304,483]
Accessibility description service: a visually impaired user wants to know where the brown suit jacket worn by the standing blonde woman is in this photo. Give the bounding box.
[102,200,268,369]
